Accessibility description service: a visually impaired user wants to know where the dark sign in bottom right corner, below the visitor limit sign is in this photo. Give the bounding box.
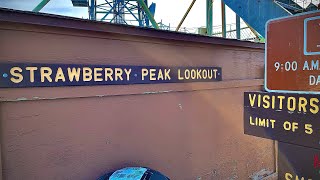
[278,142,320,180]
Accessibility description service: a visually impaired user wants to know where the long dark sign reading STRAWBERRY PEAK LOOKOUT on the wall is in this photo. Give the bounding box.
[0,63,222,88]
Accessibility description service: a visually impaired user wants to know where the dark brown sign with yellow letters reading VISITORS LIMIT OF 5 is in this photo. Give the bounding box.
[244,92,320,149]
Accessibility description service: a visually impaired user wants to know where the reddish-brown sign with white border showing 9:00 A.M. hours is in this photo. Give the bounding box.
[265,11,320,93]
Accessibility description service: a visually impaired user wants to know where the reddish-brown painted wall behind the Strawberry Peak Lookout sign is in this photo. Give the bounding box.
[0,11,275,180]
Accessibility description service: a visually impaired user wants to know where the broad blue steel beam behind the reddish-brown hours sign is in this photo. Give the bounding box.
[224,0,290,37]
